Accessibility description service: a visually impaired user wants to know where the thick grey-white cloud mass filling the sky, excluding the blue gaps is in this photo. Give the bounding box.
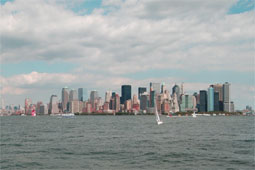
[0,0,255,109]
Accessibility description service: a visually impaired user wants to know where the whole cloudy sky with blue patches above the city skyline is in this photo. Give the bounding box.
[0,0,255,109]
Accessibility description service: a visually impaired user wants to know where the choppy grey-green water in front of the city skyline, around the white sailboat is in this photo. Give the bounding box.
[0,116,255,169]
